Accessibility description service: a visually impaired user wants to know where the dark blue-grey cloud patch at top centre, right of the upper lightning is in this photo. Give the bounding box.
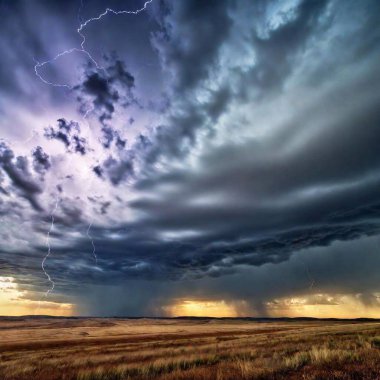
[156,0,233,93]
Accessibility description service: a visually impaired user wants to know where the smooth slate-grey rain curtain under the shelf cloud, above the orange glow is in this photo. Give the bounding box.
[73,238,380,316]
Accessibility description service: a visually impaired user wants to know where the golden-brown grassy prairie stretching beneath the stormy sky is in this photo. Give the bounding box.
[0,318,380,380]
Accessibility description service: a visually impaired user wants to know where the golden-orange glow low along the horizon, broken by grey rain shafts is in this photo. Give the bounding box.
[0,276,380,319]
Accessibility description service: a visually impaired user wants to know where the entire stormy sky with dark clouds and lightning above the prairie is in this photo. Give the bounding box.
[0,0,380,317]
